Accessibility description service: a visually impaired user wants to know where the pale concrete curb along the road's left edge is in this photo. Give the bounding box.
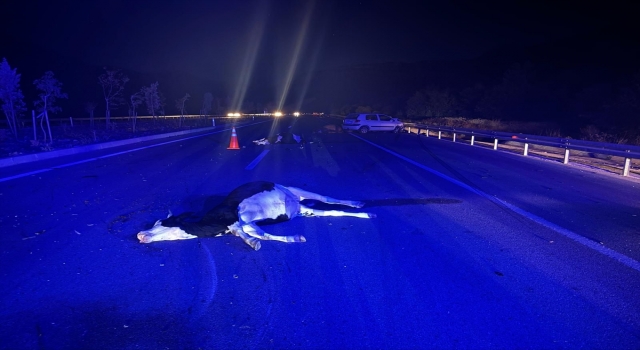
[0,126,215,168]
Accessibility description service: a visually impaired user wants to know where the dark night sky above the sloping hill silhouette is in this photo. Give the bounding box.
[0,0,639,116]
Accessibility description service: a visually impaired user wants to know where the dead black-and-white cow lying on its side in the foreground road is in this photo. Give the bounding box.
[138,181,375,250]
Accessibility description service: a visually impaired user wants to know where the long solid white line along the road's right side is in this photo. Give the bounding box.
[351,134,640,272]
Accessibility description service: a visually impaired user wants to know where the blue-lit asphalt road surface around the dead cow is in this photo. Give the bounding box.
[0,117,640,349]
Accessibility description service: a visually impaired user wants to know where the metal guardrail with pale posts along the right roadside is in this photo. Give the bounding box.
[405,123,640,176]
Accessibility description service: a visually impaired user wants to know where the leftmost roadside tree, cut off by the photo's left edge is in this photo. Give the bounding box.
[0,58,26,138]
